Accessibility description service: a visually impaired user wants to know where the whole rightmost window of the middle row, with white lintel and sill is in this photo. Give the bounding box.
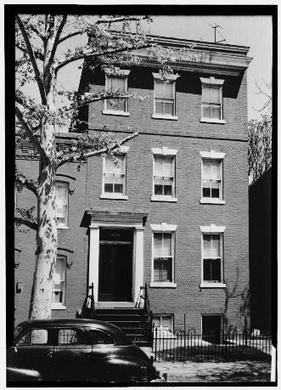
[200,151,225,204]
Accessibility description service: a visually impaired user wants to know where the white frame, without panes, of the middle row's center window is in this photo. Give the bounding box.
[150,146,177,202]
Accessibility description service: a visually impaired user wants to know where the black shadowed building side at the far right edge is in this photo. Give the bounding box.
[249,169,273,334]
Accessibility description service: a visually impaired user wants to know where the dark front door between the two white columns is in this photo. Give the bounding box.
[99,229,133,302]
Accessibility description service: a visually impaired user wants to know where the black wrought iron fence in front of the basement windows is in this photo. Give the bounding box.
[153,328,271,362]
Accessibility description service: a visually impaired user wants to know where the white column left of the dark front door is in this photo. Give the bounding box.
[88,223,100,302]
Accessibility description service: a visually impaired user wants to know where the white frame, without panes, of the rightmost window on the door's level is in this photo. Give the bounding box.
[200,224,226,288]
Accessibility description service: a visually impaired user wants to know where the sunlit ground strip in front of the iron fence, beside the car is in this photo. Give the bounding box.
[143,348,271,383]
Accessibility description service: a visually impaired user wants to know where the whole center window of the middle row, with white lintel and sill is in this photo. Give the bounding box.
[151,148,177,202]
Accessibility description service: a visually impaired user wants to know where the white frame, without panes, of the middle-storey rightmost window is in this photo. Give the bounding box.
[199,150,225,205]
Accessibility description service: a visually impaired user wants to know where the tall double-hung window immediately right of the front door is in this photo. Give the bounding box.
[151,223,176,287]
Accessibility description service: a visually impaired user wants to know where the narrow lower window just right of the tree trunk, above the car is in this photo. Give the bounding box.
[52,255,66,309]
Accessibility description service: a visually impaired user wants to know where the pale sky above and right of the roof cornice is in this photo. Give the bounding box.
[60,16,272,120]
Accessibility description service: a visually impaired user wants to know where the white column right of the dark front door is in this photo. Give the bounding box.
[134,226,144,301]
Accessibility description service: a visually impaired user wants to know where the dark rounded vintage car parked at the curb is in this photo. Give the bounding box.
[7,319,158,383]
